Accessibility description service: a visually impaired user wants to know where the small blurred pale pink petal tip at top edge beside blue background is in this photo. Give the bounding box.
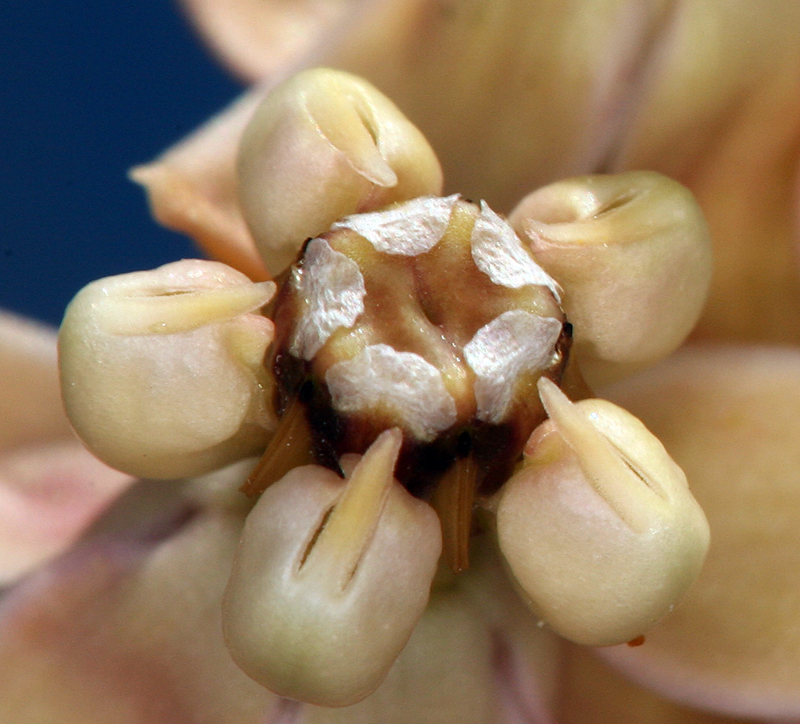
[181,0,352,82]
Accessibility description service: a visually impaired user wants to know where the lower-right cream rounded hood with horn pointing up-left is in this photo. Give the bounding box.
[497,379,709,646]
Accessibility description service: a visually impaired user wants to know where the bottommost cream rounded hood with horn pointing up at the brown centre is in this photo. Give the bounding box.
[224,428,441,706]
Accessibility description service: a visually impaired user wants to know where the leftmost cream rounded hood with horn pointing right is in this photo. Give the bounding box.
[59,260,275,478]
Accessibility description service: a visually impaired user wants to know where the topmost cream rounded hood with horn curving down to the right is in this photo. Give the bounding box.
[238,69,442,275]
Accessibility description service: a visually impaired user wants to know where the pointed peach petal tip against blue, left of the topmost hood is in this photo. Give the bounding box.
[130,89,270,281]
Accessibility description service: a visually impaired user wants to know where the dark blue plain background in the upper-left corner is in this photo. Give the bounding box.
[0,0,241,324]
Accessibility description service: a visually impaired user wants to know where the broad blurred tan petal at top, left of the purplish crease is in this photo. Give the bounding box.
[324,0,671,212]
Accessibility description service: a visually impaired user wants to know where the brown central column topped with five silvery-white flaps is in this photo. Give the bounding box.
[251,196,570,568]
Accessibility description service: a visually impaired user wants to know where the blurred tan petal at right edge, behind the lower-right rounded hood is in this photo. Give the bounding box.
[603,347,800,717]
